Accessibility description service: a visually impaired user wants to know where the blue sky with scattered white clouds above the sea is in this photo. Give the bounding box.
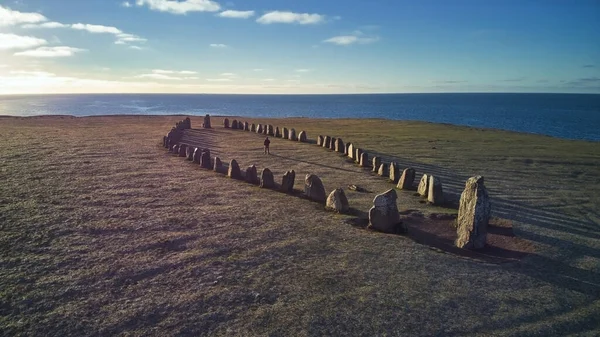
[0,0,600,94]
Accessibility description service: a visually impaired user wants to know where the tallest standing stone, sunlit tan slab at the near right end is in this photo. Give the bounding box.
[456,176,492,249]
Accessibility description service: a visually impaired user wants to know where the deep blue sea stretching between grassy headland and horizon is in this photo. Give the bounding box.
[0,93,600,142]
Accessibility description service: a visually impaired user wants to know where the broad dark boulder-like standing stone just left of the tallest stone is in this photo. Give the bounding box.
[369,189,406,234]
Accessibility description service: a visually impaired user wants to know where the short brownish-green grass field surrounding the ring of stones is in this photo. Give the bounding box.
[0,116,600,336]
